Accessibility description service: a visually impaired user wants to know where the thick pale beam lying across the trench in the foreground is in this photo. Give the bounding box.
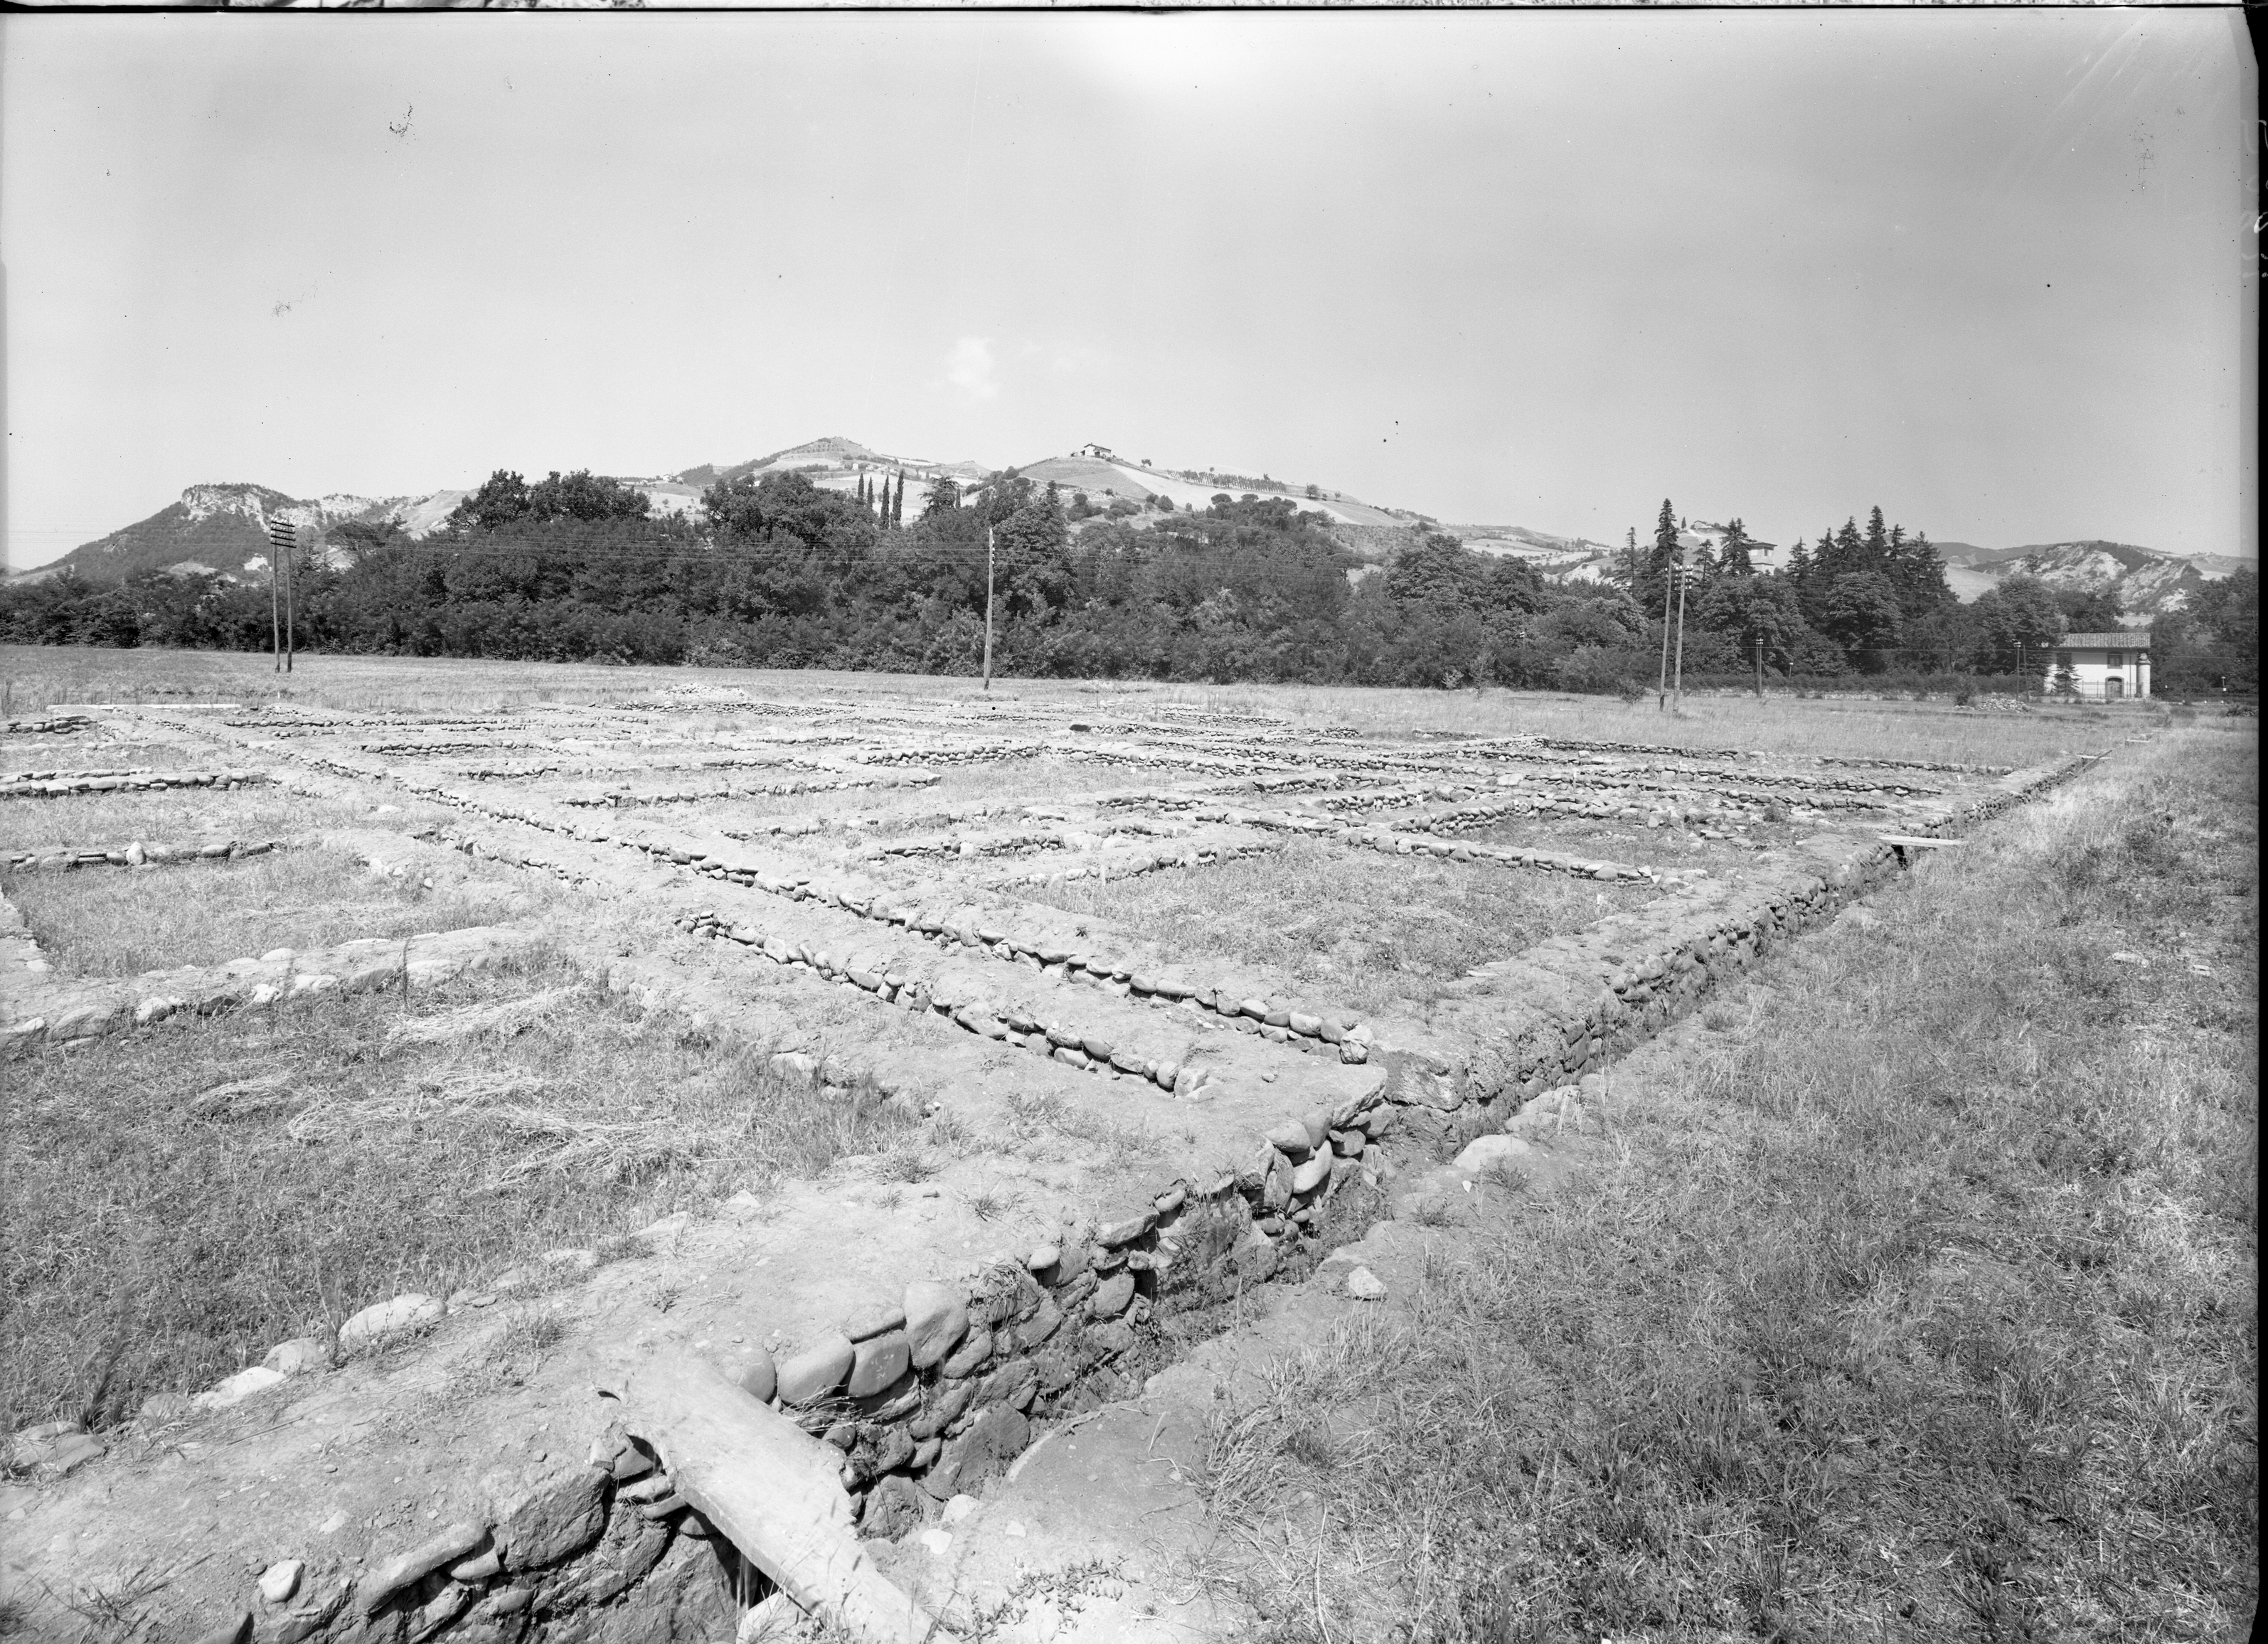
[622,1356,952,1644]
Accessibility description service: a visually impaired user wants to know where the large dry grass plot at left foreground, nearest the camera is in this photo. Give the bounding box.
[0,959,916,1431]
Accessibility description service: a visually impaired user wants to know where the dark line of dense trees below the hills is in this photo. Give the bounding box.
[0,469,2259,696]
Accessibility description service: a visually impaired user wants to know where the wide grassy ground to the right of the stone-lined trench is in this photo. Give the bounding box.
[1207,728,2259,1642]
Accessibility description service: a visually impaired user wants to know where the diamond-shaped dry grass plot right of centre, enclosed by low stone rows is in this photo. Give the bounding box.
[1025,839,1660,1013]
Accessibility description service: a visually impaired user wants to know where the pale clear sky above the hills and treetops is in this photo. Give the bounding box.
[0,9,2259,569]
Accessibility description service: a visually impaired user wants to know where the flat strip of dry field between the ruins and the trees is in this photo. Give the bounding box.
[0,646,2141,764]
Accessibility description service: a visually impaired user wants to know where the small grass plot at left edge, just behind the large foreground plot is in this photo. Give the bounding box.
[7,848,555,975]
